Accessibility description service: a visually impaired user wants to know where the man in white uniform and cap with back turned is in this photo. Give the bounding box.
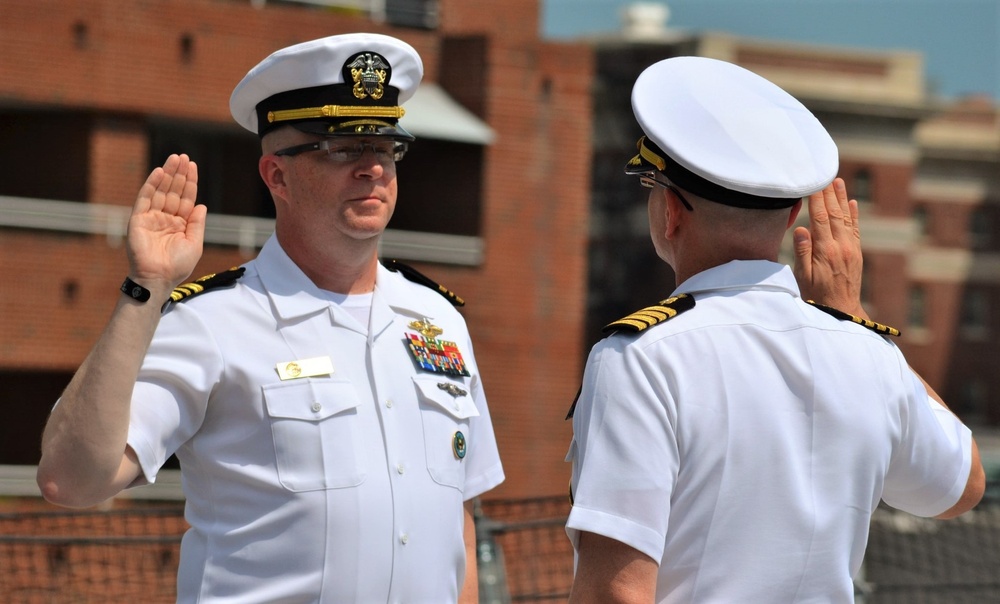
[567,57,984,604]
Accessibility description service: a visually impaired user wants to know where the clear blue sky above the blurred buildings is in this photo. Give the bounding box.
[541,0,1000,101]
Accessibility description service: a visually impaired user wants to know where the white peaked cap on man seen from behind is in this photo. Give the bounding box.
[625,57,840,209]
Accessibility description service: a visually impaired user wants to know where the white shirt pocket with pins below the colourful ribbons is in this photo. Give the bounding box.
[413,375,479,491]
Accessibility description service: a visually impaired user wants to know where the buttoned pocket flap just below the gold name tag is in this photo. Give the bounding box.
[264,379,361,421]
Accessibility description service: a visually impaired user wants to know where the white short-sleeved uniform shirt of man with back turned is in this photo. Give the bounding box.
[567,261,971,604]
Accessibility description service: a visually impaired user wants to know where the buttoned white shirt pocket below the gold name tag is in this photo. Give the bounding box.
[264,378,365,491]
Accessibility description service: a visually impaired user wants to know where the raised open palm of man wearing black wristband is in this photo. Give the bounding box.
[127,154,207,290]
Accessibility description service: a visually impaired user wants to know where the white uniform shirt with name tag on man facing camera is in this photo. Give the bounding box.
[128,237,504,604]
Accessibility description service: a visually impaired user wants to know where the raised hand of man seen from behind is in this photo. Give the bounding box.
[792,178,867,318]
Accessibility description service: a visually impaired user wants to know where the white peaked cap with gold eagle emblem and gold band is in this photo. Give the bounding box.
[229,33,424,140]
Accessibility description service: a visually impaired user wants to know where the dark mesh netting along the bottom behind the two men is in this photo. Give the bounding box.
[0,496,1000,604]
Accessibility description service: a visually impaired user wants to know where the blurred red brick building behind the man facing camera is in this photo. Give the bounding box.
[0,0,592,497]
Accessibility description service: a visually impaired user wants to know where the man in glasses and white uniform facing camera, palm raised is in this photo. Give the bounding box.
[38,34,504,602]
